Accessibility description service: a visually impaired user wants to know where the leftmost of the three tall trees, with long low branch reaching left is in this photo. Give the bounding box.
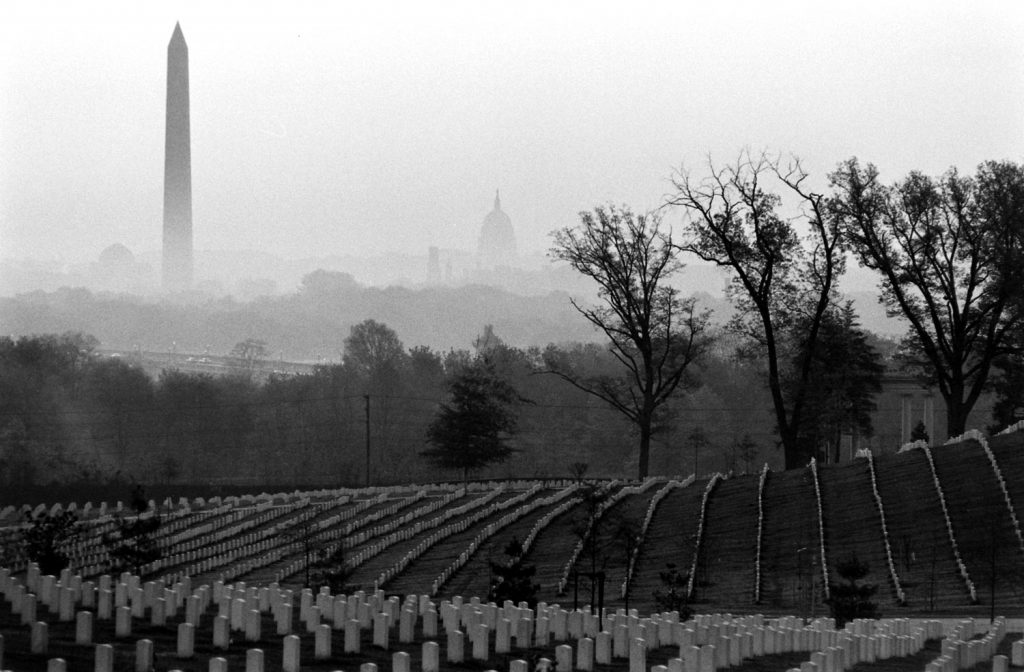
[545,206,708,478]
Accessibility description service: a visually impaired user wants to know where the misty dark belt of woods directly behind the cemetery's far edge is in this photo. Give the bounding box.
[0,321,790,502]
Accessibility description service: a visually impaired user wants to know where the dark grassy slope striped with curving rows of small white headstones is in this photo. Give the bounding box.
[0,432,1024,616]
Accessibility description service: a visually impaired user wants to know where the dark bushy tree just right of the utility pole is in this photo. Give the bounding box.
[420,360,523,479]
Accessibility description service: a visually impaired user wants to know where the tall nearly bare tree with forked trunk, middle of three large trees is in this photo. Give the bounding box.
[668,152,844,469]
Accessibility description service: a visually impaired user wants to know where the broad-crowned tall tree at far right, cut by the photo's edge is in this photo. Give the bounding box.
[828,159,1024,436]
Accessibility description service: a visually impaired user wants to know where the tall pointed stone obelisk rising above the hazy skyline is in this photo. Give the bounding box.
[163,24,193,291]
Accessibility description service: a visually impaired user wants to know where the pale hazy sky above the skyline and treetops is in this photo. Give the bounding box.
[0,0,1024,260]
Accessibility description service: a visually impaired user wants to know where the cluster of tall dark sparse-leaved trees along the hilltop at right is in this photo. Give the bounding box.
[551,153,1024,476]
